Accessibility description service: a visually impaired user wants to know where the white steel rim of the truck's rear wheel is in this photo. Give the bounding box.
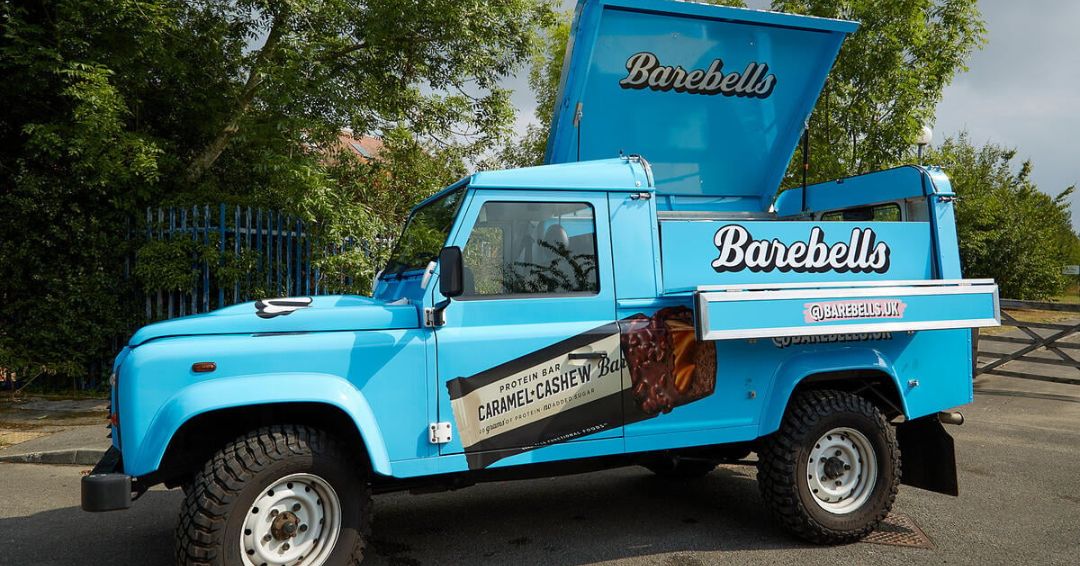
[807,427,878,515]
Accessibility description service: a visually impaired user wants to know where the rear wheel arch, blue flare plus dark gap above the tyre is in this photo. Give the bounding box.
[758,348,908,436]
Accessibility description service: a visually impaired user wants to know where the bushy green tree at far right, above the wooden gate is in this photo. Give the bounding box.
[927,133,1080,299]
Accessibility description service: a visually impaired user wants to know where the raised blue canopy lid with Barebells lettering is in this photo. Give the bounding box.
[545,0,859,210]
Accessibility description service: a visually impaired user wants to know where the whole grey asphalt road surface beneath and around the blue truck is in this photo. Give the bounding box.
[0,378,1080,566]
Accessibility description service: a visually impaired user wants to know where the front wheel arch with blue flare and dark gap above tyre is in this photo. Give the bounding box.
[124,374,391,482]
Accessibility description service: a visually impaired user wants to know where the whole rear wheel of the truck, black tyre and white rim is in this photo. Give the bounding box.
[757,391,900,544]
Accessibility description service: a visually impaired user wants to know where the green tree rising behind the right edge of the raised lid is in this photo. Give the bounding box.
[772,0,986,184]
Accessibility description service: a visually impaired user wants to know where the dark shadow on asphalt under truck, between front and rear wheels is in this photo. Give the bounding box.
[365,467,806,566]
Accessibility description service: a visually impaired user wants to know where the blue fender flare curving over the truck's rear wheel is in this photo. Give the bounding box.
[758,347,908,436]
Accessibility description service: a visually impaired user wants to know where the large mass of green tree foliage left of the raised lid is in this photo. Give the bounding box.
[0,0,552,384]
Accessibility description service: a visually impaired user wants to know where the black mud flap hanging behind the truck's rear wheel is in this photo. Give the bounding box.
[896,415,960,496]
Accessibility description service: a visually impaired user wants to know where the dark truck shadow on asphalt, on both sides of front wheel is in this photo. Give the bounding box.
[0,467,805,566]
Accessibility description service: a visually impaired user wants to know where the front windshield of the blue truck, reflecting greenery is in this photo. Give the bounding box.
[382,185,465,277]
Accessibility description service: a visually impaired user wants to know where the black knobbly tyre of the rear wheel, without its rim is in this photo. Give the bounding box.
[757,390,900,544]
